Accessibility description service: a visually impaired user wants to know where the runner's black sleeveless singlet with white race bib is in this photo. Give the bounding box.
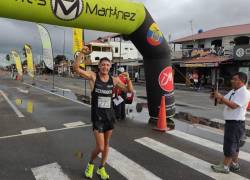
[91,73,115,123]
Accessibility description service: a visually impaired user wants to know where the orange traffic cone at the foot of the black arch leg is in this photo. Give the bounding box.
[154,96,168,132]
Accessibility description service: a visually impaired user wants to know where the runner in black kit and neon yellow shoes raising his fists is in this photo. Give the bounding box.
[73,47,133,180]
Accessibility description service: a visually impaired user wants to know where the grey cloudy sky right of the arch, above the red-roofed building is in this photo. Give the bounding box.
[140,0,250,38]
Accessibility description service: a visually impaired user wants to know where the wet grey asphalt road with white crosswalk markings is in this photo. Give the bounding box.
[0,72,250,180]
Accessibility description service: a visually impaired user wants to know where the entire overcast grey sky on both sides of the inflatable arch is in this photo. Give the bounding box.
[0,0,250,58]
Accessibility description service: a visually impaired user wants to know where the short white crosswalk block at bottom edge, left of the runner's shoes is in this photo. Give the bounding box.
[31,163,70,180]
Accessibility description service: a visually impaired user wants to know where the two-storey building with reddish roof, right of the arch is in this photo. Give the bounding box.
[172,24,250,86]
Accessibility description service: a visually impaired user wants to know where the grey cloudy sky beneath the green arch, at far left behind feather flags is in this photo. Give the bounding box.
[0,18,72,56]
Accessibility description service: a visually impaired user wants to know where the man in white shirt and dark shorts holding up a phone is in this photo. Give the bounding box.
[211,72,250,174]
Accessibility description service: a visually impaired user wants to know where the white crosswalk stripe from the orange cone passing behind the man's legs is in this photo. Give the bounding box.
[167,130,250,162]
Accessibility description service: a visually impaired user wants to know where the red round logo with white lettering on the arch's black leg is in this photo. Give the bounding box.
[159,66,174,92]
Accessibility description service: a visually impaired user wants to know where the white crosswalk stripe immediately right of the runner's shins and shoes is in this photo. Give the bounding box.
[99,147,161,180]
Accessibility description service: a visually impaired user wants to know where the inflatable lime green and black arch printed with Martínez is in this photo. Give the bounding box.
[0,0,174,120]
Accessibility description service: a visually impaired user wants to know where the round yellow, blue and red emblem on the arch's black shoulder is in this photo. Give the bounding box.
[147,23,163,46]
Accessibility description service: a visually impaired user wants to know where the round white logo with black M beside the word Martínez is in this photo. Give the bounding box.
[51,0,83,20]
